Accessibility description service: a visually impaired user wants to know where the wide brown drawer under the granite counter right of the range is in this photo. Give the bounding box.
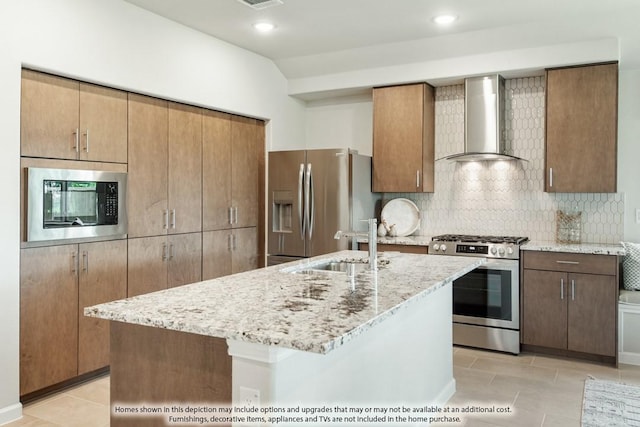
[522,251,618,276]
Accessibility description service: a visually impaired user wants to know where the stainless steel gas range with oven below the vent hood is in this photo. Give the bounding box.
[429,234,529,354]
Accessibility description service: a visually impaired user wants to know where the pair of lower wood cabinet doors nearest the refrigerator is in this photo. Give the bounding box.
[202,227,258,280]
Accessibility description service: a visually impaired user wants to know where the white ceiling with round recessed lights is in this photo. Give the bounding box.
[126,0,640,78]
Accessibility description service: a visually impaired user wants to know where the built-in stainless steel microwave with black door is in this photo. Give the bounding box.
[26,168,127,243]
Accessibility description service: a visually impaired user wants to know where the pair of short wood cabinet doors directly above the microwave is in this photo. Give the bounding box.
[20,69,127,163]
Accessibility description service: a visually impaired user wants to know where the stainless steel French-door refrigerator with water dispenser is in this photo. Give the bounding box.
[267,149,381,265]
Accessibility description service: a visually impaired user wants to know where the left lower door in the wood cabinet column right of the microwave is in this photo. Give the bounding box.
[127,236,169,297]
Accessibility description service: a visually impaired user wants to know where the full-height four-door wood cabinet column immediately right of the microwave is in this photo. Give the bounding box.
[127,94,202,296]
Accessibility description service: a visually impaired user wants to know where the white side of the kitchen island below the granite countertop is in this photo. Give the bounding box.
[228,284,455,414]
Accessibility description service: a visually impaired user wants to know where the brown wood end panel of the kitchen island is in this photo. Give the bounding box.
[111,322,232,427]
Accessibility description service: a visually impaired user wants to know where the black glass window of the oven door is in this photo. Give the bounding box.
[453,268,513,320]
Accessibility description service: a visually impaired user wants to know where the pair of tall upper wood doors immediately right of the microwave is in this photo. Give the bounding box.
[127,94,202,237]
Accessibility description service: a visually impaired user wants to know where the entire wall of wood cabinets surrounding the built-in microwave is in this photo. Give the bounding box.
[20,70,265,399]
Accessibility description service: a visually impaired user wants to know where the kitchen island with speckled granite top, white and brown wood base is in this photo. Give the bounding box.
[85,251,485,426]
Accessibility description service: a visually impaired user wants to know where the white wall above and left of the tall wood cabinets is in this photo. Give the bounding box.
[0,0,305,424]
